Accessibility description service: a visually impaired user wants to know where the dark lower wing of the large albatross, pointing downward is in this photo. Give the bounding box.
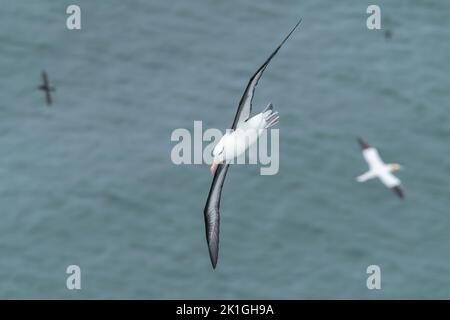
[203,164,228,269]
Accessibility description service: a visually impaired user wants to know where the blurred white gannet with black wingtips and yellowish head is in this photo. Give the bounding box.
[356,138,403,198]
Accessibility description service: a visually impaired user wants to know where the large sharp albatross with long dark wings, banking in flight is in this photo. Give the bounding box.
[203,19,301,269]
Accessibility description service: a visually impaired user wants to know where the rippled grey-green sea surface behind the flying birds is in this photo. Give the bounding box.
[0,0,450,299]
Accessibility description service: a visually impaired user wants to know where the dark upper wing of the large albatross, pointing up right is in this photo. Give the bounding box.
[231,19,302,129]
